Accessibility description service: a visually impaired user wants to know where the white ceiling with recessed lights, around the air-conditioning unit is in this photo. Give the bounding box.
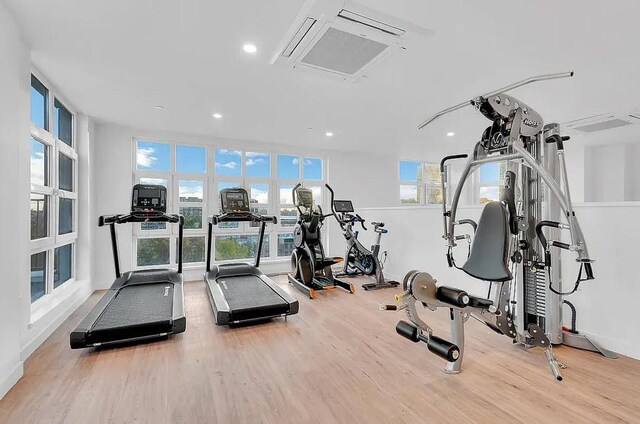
[5,0,640,154]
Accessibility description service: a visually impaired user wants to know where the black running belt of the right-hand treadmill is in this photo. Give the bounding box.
[218,275,289,311]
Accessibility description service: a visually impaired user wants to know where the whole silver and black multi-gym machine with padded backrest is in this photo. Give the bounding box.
[381,72,616,380]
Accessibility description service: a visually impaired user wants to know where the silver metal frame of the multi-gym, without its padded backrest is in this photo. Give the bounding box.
[381,72,615,380]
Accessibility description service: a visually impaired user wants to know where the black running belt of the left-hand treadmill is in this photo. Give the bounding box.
[90,282,173,342]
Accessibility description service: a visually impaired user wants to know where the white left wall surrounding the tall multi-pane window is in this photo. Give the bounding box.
[0,2,92,398]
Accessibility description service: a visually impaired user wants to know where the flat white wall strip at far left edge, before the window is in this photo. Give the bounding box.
[0,3,30,398]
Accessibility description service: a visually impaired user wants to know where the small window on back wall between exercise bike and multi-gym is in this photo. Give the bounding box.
[398,160,442,205]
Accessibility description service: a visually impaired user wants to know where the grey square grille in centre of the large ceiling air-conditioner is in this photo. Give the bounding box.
[300,28,389,75]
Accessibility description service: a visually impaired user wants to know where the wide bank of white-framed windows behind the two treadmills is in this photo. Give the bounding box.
[134,140,324,267]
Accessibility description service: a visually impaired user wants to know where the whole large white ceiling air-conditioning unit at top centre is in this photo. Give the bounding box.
[271,0,431,81]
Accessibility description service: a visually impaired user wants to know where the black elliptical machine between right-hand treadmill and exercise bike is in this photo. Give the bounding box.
[288,183,356,299]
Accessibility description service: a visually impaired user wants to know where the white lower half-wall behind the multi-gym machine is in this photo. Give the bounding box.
[352,203,640,358]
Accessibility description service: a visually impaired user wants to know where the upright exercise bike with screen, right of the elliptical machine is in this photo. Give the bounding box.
[329,188,400,290]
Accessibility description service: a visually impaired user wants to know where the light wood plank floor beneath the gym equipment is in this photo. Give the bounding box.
[0,276,640,424]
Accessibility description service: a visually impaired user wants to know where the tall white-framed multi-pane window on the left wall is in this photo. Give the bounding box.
[29,75,78,302]
